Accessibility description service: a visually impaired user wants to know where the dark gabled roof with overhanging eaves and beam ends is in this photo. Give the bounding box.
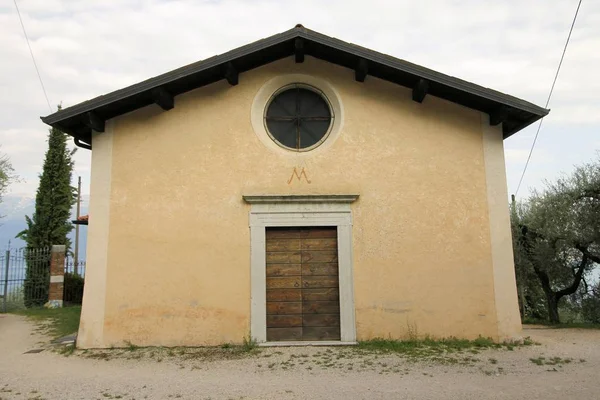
[42,25,549,147]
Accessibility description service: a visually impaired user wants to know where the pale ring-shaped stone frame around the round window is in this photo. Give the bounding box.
[251,74,344,157]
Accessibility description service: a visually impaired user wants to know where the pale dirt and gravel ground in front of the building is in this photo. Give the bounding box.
[0,315,600,400]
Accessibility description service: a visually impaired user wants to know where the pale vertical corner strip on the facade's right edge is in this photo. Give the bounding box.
[481,113,521,341]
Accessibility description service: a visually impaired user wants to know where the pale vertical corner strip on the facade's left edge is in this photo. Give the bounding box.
[77,120,114,348]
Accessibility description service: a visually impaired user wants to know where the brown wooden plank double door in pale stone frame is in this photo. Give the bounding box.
[266,227,340,341]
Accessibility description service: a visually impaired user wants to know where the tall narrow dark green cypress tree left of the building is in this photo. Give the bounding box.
[18,121,75,307]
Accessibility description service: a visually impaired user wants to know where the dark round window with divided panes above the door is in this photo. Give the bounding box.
[264,84,334,151]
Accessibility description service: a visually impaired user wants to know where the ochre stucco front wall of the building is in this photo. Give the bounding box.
[78,57,521,348]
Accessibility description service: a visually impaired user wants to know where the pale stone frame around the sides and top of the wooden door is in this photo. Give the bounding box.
[250,201,356,343]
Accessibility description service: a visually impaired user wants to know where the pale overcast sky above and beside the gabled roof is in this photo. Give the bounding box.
[0,0,600,197]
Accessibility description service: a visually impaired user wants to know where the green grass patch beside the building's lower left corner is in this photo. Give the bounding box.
[15,306,81,339]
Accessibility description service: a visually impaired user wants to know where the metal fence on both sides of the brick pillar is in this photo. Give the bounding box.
[0,248,85,312]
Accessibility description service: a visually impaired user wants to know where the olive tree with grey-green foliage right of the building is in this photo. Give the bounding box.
[511,155,600,323]
